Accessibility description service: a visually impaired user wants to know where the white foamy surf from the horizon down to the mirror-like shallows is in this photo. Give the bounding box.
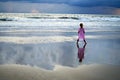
[0,13,120,43]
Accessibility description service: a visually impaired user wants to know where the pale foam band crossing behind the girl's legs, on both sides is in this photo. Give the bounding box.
[0,35,120,44]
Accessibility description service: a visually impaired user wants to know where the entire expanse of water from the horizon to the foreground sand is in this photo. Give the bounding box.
[0,13,120,70]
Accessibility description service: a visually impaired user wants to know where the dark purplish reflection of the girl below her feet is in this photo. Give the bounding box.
[77,43,86,62]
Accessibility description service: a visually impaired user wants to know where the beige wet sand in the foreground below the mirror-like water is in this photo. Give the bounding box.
[0,64,120,80]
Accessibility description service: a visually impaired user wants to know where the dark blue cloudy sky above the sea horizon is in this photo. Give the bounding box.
[0,0,120,15]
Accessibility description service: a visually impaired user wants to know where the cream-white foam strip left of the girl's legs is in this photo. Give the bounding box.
[0,36,76,44]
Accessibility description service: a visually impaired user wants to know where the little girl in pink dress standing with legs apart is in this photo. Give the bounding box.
[77,23,87,44]
